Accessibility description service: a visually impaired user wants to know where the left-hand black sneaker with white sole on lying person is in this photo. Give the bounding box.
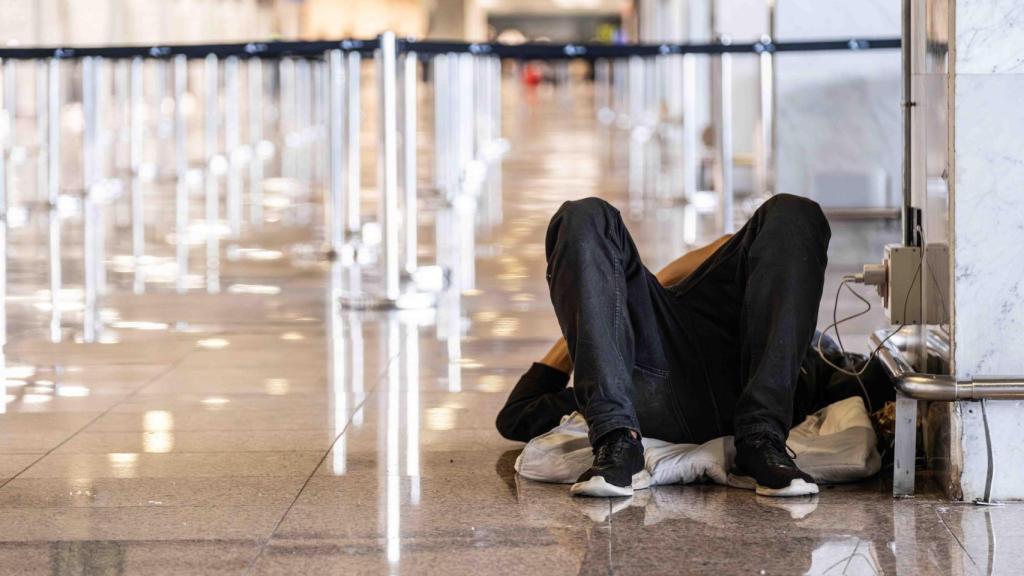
[569,428,650,498]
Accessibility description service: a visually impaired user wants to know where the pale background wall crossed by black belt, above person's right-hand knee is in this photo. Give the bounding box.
[775,0,902,205]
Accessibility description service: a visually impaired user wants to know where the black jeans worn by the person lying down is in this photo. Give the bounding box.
[546,195,831,443]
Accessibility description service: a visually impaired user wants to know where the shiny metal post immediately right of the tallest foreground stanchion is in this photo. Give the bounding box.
[401,52,420,275]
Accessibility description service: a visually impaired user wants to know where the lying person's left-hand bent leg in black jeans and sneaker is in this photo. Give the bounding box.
[546,198,679,496]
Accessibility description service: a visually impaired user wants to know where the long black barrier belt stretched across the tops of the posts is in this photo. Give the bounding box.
[0,38,900,59]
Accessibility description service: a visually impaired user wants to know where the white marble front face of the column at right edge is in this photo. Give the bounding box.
[946,0,1024,500]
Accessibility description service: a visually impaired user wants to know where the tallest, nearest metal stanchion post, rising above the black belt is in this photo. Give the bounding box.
[377,32,400,301]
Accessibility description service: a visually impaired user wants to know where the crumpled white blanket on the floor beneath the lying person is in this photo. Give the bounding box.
[515,397,882,485]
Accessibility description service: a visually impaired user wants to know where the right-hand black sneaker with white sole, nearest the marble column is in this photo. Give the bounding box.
[733,434,818,496]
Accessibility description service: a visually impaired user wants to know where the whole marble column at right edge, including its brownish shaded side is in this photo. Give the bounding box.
[913,0,1024,501]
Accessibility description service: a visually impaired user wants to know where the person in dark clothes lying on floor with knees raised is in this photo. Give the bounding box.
[497,194,894,496]
